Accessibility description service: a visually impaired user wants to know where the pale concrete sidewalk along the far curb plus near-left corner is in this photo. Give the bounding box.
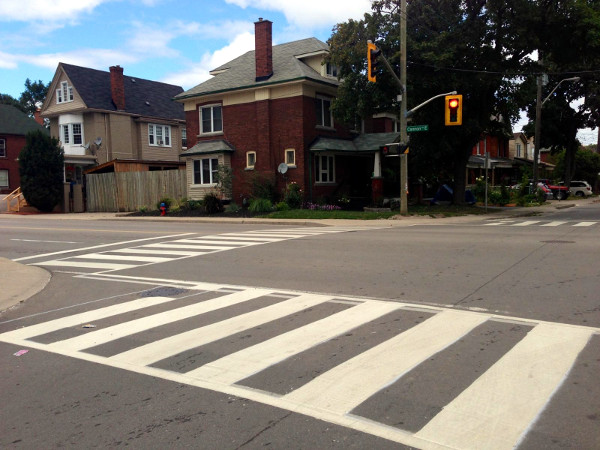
[0,198,595,314]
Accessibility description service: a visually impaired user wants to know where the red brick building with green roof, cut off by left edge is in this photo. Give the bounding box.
[0,104,48,194]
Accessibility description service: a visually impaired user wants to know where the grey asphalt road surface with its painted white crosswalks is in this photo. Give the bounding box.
[0,202,600,449]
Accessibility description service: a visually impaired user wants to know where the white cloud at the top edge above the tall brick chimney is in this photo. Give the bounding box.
[225,0,371,29]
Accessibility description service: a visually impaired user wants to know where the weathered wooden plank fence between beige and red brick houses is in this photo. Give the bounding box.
[86,170,187,212]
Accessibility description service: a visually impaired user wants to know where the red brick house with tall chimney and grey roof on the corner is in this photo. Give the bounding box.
[175,19,399,203]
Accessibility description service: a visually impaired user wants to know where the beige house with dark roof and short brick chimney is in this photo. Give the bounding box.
[40,63,185,184]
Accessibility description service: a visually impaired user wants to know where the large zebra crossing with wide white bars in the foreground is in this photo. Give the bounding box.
[0,280,600,449]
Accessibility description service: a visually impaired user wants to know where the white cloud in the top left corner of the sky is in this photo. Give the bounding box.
[0,0,110,22]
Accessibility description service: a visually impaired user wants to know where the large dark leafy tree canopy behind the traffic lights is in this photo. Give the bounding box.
[329,0,600,202]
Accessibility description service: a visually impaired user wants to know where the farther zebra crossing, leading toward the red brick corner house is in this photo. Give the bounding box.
[32,227,373,272]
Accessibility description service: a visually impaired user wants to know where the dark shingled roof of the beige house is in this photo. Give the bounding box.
[59,63,185,120]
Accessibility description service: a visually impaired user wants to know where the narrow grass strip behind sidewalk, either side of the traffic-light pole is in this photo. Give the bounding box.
[256,205,485,220]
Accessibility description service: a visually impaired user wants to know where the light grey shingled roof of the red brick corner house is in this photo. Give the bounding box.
[175,38,339,100]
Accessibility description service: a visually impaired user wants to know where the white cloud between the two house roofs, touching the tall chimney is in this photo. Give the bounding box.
[161,32,254,89]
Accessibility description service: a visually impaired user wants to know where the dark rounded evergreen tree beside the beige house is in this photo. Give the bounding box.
[19,130,64,212]
